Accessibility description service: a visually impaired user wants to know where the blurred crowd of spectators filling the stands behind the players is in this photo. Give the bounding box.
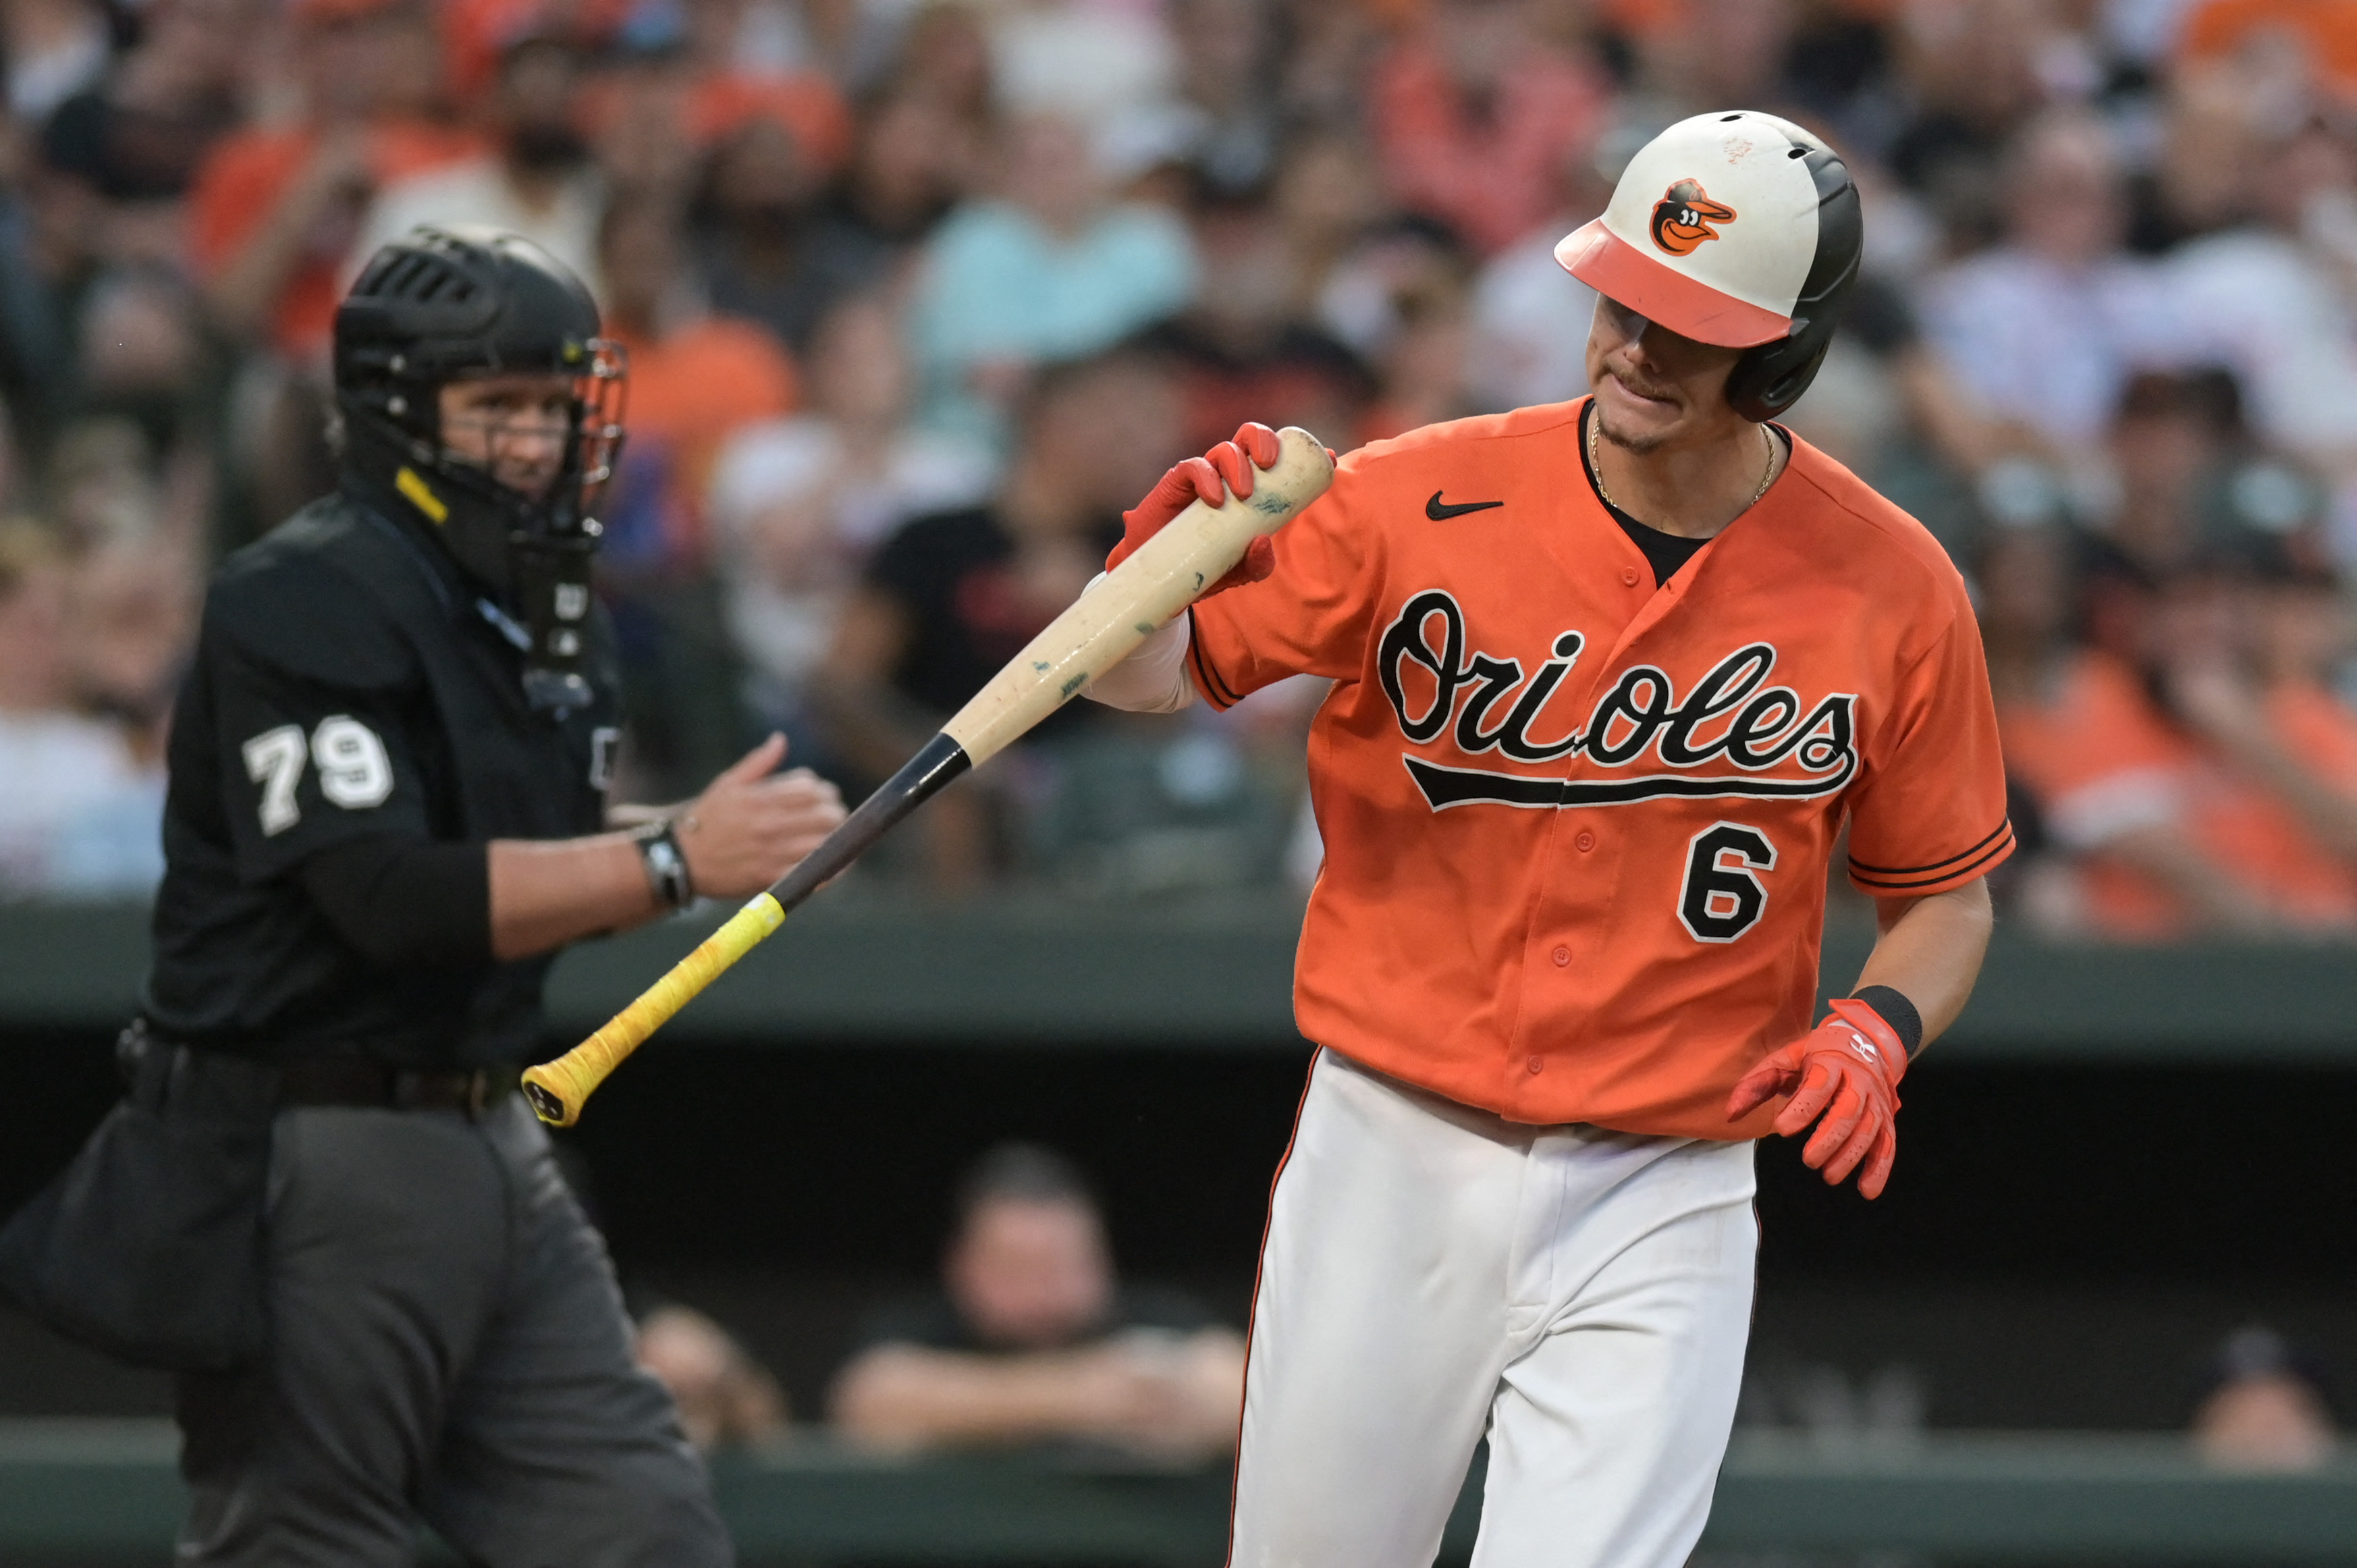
[0,0,2357,941]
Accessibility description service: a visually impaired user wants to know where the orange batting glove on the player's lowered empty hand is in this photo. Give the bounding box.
[1728,998,1907,1198]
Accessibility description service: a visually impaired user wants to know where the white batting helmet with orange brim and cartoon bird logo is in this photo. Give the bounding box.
[1556,109,1864,420]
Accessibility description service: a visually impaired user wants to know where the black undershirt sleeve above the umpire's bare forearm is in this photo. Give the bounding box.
[297,835,493,969]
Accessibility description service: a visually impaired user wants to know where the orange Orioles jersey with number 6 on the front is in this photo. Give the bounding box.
[1188,398,2013,1139]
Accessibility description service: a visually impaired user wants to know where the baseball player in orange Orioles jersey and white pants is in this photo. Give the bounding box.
[1093,113,2013,1568]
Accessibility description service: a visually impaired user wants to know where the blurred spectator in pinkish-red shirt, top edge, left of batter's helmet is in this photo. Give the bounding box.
[1367,0,1605,252]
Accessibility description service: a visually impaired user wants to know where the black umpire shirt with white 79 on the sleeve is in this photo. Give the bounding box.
[144,474,618,1068]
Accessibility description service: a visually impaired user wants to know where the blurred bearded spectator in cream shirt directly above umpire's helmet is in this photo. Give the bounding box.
[346,33,605,300]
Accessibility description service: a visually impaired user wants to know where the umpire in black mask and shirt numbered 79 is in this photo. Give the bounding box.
[48,229,842,1568]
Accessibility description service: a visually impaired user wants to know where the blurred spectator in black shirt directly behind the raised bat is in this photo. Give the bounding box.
[811,351,1185,886]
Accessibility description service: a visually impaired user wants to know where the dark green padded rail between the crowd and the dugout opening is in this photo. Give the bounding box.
[0,889,2357,1063]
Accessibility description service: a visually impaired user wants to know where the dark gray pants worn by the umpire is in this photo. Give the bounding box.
[179,1096,733,1568]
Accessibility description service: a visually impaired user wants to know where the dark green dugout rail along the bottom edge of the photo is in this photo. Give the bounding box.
[0,1422,2357,1568]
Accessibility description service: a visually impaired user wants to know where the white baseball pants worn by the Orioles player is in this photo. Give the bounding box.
[1228,1052,1758,1568]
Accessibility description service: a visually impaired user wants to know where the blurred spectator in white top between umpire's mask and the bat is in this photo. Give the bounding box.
[709,295,992,766]
